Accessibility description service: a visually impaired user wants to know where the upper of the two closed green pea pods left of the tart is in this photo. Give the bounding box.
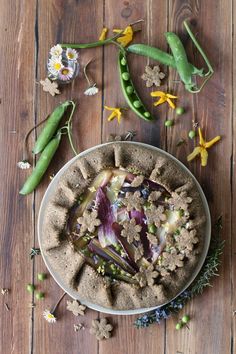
[32,101,72,154]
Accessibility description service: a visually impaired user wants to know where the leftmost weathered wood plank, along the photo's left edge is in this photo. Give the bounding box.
[0,0,35,354]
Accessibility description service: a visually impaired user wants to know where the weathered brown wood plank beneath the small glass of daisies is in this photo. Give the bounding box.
[34,0,103,354]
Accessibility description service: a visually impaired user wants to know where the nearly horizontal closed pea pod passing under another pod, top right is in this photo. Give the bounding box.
[126,44,204,77]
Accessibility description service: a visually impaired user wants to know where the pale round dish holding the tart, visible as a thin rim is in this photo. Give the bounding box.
[38,142,211,315]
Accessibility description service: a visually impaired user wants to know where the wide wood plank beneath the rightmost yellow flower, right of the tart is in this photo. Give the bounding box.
[166,1,232,354]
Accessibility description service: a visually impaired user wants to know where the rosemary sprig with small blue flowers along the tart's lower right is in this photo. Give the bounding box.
[134,217,225,328]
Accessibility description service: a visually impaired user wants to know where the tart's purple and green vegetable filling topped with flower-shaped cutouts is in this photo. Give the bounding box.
[66,168,198,287]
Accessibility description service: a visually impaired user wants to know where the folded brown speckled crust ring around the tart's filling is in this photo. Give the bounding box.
[42,142,206,310]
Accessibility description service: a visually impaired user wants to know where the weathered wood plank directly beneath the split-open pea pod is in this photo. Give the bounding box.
[99,0,167,354]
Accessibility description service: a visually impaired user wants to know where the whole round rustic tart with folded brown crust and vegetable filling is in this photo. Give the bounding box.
[42,142,206,310]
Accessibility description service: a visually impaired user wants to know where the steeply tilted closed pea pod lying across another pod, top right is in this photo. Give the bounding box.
[165,32,195,88]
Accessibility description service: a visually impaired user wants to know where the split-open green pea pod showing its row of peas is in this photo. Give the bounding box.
[118,51,153,121]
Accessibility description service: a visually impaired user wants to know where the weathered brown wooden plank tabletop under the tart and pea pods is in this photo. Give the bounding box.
[0,0,236,354]
